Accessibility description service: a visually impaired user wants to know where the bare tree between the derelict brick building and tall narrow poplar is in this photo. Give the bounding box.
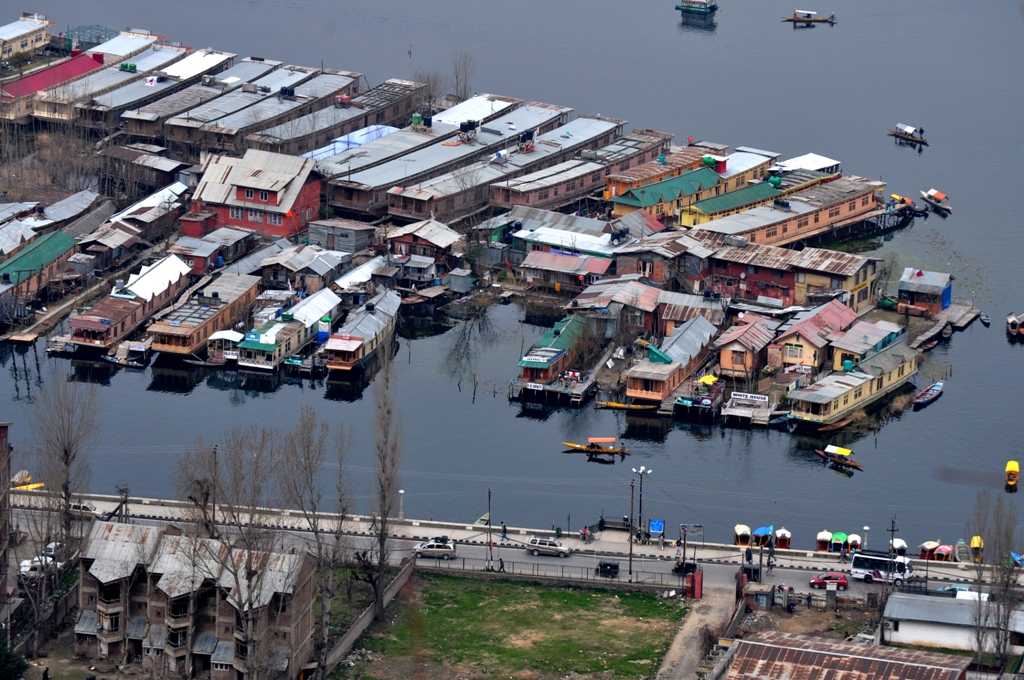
[281,406,352,679]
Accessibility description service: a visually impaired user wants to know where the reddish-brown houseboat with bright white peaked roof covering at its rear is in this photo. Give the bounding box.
[68,255,190,352]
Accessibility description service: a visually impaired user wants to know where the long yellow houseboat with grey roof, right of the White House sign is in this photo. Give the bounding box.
[790,341,921,426]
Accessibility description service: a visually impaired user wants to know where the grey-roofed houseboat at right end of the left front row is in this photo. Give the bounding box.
[324,291,401,377]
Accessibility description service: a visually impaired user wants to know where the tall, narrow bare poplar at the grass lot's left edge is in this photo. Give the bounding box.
[355,343,402,619]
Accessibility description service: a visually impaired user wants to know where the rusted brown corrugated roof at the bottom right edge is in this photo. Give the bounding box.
[724,631,971,680]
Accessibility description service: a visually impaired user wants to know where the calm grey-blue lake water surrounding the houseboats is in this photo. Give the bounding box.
[0,0,1024,547]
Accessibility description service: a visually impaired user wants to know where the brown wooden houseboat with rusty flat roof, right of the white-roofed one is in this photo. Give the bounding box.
[148,273,260,355]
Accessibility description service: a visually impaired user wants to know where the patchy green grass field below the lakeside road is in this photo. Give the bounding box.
[364,575,684,678]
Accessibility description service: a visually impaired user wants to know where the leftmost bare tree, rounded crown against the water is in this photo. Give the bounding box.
[32,367,100,544]
